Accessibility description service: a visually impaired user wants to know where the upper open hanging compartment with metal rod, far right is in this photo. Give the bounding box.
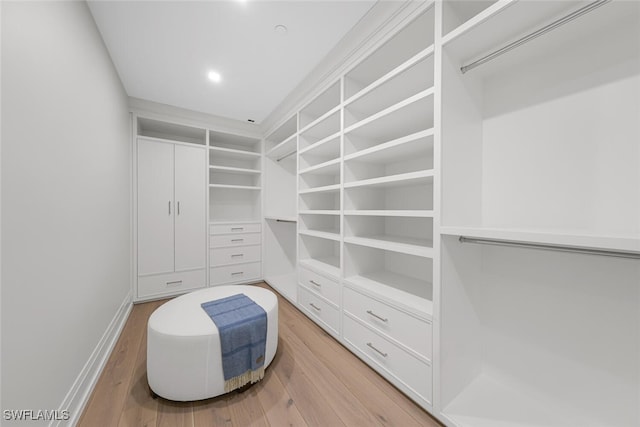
[441,1,640,250]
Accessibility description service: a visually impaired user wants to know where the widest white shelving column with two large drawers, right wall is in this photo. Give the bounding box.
[343,4,438,407]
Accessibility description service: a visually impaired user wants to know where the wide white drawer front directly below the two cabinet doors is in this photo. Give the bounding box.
[138,269,207,298]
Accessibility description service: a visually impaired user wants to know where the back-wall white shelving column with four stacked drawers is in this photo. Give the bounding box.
[209,131,262,285]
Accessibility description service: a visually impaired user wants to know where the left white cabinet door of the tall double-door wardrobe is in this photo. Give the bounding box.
[138,139,174,276]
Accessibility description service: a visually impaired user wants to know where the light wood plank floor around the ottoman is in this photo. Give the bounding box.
[78,284,440,427]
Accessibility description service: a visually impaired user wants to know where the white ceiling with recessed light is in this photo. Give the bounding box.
[89,0,375,123]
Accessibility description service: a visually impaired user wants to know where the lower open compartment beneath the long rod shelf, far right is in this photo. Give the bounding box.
[440,236,640,427]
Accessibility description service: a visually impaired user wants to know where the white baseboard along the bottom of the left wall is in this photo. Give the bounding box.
[49,292,133,427]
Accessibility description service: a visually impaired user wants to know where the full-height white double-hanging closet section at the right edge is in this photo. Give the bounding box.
[440,1,640,427]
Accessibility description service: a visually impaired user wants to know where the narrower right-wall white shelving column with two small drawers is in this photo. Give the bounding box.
[298,81,342,336]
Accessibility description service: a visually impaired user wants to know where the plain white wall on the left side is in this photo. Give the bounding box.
[0,2,131,425]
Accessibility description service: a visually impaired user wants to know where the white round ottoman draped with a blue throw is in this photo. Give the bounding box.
[147,285,278,401]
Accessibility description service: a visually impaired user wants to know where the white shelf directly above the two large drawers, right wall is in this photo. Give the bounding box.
[344,270,433,320]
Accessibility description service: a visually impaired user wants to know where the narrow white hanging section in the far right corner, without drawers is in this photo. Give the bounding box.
[264,115,298,303]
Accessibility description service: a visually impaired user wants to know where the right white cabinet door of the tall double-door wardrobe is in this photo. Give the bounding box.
[175,145,207,271]
